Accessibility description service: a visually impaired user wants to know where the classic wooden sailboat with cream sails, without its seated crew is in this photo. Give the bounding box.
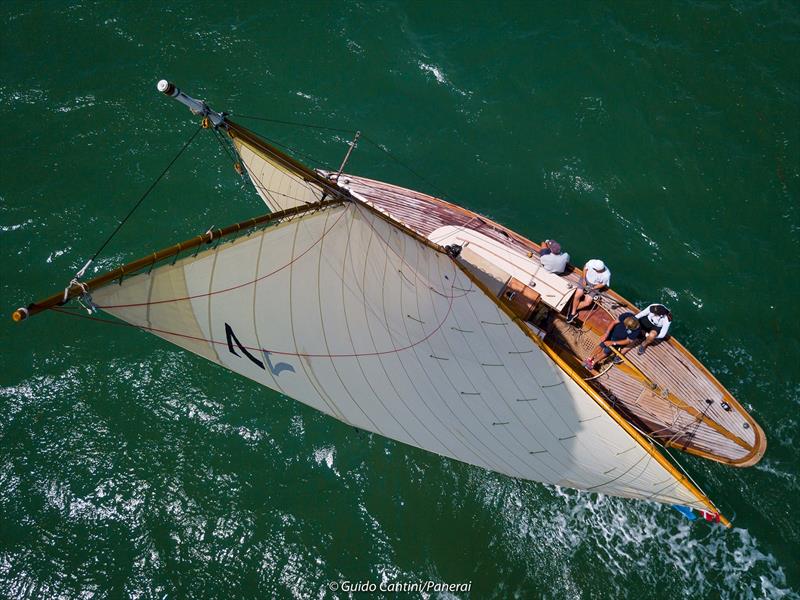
[13,80,766,526]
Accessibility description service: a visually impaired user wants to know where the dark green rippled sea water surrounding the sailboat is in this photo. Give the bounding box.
[0,0,800,599]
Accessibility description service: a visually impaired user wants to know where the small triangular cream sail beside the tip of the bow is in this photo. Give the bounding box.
[231,129,323,212]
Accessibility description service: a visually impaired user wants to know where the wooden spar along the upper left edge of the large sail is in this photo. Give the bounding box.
[11,198,345,322]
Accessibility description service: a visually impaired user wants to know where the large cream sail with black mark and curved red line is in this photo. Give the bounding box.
[93,202,709,508]
